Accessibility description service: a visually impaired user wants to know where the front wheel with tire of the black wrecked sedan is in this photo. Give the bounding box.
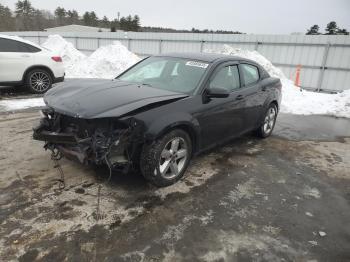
[140,129,192,187]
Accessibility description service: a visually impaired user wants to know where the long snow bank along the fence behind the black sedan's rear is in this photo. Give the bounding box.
[206,45,350,118]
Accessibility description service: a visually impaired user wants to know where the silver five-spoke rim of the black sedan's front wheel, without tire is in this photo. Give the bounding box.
[158,137,188,179]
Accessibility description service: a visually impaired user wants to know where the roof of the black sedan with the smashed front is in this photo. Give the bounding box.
[156,53,256,64]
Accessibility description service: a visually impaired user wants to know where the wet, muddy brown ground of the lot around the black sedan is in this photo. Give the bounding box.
[0,111,350,261]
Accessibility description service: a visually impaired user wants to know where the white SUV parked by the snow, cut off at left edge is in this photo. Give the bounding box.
[0,35,64,94]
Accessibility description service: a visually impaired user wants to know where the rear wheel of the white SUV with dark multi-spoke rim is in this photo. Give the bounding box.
[25,69,52,94]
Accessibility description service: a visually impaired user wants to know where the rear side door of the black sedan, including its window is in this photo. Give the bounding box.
[239,62,265,131]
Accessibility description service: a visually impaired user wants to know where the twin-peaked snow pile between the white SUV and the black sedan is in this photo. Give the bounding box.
[42,35,140,78]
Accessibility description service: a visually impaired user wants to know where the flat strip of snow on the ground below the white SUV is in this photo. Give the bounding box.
[0,97,45,111]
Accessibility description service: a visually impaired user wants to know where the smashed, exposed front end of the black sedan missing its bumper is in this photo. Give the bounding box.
[33,109,144,172]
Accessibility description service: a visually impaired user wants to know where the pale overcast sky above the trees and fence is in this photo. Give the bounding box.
[0,0,350,34]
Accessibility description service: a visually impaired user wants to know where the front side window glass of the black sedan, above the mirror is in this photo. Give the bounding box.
[209,65,240,92]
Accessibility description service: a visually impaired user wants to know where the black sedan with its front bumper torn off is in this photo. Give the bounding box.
[33,54,281,186]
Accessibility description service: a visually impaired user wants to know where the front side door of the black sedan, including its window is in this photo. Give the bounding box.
[197,63,245,148]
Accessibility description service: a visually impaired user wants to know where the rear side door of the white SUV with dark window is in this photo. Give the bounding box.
[0,38,36,82]
